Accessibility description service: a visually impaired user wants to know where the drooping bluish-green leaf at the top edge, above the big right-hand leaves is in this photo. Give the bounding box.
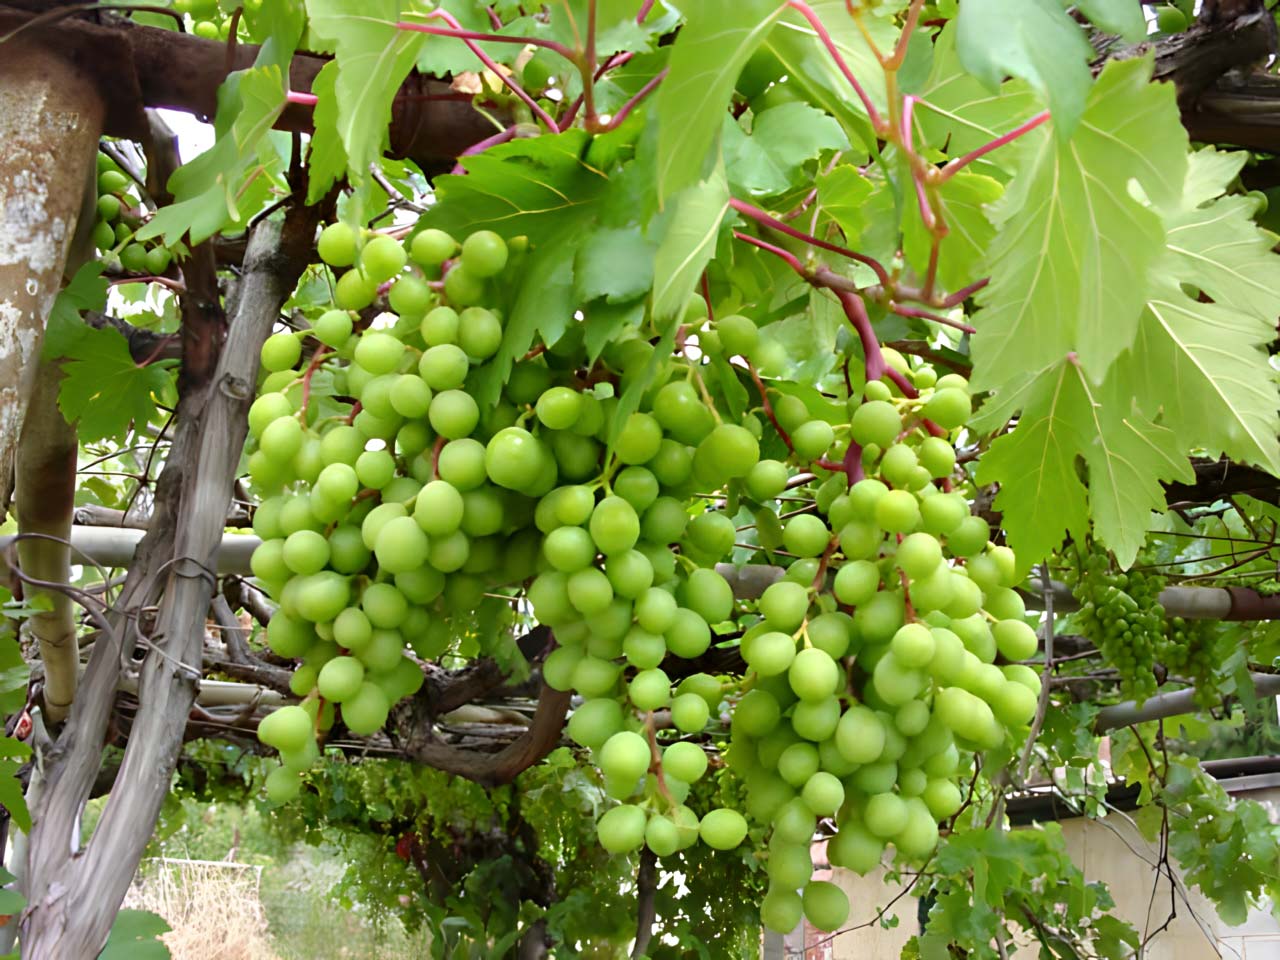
[956,0,1093,141]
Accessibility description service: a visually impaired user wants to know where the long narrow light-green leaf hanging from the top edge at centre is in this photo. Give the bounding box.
[655,0,782,205]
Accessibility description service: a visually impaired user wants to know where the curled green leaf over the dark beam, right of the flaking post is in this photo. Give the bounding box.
[136,64,285,244]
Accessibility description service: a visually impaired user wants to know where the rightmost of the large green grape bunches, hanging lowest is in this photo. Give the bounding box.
[727,371,1039,931]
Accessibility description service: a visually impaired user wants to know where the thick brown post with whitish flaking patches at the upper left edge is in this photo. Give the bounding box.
[0,40,104,527]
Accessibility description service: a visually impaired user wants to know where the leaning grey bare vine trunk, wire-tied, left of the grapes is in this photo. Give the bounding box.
[22,209,315,960]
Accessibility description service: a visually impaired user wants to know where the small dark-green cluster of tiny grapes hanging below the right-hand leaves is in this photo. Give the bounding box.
[1071,545,1165,701]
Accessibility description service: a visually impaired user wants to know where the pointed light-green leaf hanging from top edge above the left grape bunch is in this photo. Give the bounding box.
[307,0,424,192]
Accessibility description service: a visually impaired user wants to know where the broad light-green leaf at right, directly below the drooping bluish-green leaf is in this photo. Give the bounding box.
[973,59,1187,388]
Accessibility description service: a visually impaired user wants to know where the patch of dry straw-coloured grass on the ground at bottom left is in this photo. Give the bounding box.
[124,860,279,960]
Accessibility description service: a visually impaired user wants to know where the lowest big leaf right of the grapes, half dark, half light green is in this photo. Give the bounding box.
[977,358,1193,570]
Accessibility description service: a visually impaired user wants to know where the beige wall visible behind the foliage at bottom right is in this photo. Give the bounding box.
[808,778,1280,960]
